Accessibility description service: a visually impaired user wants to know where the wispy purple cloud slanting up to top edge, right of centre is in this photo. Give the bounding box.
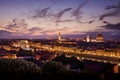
[71,1,88,21]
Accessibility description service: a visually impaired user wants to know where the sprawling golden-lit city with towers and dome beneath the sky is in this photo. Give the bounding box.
[0,32,120,62]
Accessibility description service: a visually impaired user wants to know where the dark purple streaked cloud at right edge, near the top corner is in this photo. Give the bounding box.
[99,4,120,20]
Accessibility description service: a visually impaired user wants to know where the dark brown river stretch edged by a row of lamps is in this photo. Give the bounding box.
[66,53,120,64]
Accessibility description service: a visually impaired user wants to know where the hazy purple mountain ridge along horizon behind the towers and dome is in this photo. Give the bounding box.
[0,30,120,39]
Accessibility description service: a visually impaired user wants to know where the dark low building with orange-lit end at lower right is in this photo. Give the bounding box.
[82,60,118,74]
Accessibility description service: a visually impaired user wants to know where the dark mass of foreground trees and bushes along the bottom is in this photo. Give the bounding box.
[0,59,117,80]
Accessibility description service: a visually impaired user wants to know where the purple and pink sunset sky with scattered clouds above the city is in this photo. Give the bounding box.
[0,0,120,39]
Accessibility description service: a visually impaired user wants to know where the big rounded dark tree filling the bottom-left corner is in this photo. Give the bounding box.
[0,59,41,80]
